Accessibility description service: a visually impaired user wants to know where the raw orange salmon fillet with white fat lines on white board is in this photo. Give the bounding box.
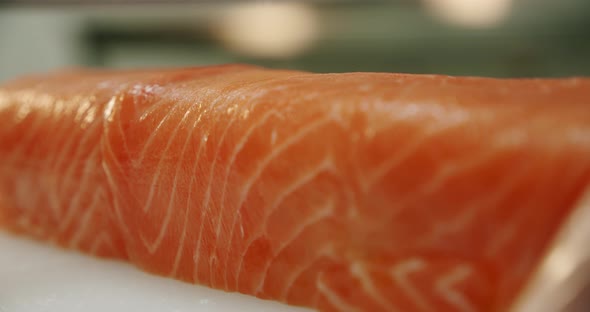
[0,65,590,312]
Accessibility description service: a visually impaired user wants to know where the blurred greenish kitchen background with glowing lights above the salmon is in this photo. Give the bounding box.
[0,0,590,81]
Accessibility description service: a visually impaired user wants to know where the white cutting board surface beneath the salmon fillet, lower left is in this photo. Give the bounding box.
[0,231,309,312]
